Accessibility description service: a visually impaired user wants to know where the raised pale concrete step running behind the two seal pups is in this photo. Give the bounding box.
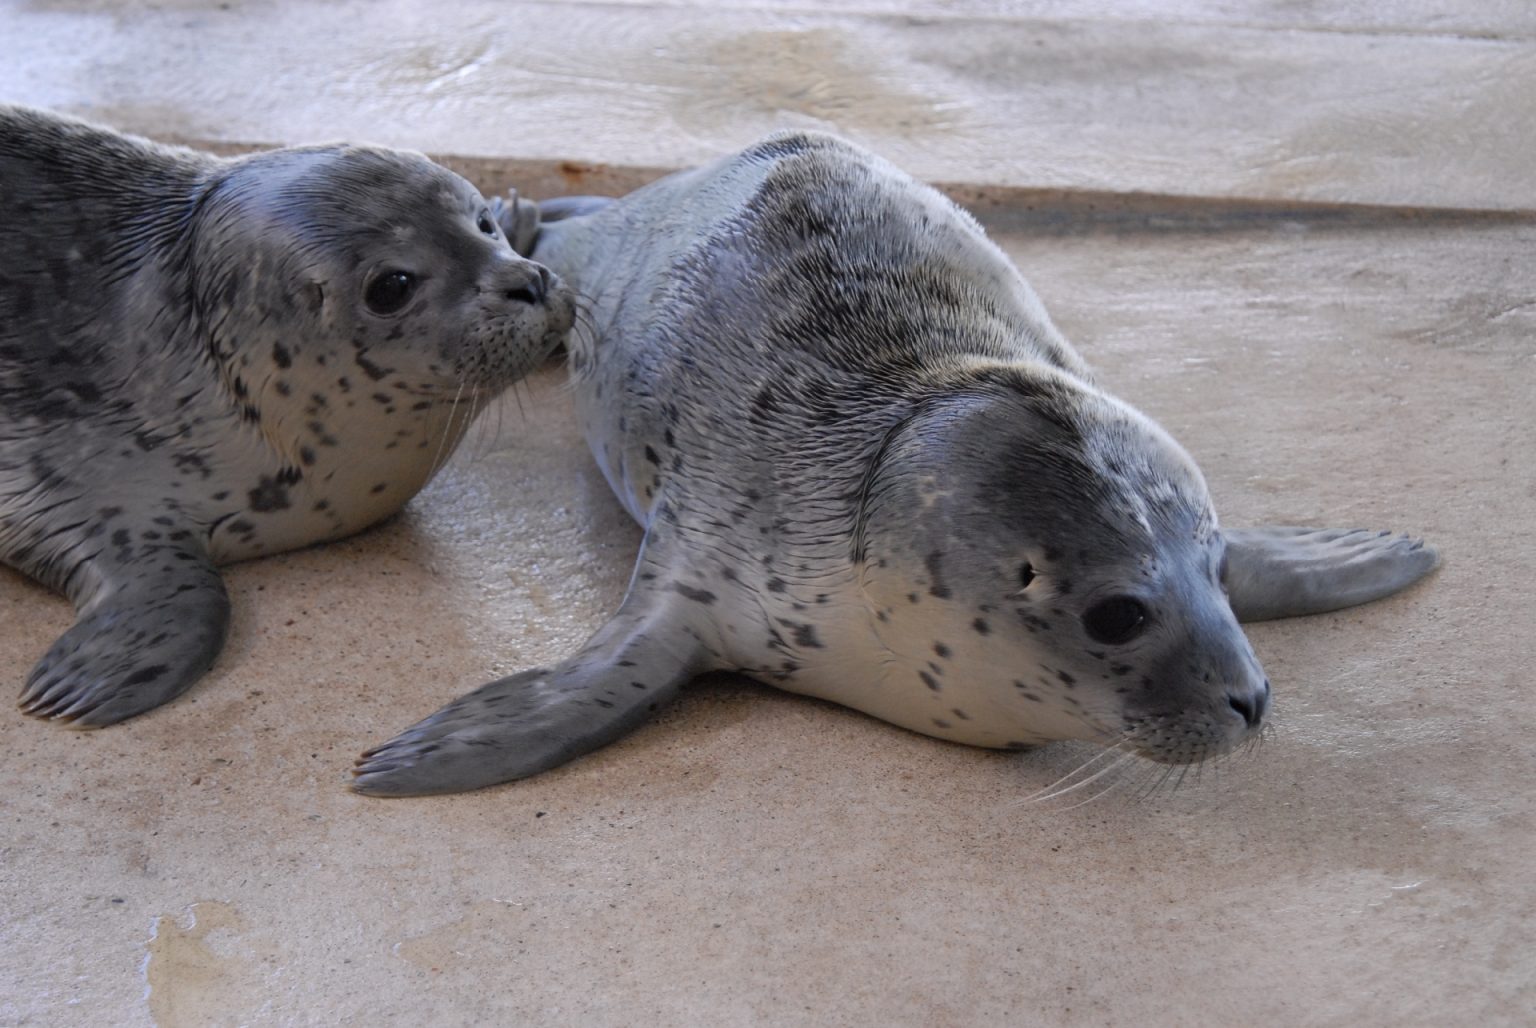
[9,0,1536,211]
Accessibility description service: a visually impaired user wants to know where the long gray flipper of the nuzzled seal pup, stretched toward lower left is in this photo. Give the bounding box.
[352,593,711,796]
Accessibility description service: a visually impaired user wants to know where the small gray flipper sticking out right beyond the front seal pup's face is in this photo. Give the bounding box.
[1221,526,1439,621]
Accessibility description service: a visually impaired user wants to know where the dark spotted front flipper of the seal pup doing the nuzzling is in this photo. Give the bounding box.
[20,544,229,728]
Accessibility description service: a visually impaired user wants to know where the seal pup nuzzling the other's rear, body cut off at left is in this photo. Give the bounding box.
[0,108,574,728]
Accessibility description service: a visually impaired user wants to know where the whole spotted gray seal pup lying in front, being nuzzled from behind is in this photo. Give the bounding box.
[353,134,1436,796]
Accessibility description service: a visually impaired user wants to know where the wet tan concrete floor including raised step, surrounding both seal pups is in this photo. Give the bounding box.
[0,0,1536,1026]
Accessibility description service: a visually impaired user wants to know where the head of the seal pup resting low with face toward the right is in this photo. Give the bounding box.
[856,376,1269,764]
